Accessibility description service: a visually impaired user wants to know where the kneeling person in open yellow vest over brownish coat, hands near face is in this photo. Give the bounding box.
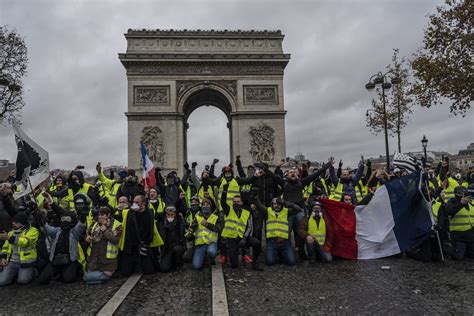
[83,207,122,284]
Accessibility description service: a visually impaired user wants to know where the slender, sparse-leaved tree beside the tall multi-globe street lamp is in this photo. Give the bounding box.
[366,48,412,152]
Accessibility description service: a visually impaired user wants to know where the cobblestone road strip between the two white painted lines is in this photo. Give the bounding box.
[117,266,212,315]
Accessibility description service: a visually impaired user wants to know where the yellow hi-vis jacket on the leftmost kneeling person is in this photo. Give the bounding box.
[0,227,39,268]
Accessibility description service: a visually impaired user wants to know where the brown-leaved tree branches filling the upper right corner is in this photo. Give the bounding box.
[411,0,474,116]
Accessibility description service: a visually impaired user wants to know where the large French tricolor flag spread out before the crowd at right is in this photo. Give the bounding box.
[321,172,434,259]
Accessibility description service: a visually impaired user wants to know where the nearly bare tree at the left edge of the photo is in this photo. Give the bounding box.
[0,26,28,124]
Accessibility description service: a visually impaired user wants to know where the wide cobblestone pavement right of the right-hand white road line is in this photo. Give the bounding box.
[224,258,474,315]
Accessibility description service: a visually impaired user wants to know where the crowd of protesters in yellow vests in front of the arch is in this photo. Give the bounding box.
[0,157,474,286]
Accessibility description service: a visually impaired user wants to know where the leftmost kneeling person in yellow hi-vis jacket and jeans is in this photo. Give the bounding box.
[0,212,39,286]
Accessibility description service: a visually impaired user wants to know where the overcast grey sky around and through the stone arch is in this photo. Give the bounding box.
[0,0,474,170]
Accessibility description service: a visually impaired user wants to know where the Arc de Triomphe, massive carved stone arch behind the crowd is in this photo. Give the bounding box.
[119,30,290,174]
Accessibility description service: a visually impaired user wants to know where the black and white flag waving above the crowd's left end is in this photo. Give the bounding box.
[12,123,49,199]
